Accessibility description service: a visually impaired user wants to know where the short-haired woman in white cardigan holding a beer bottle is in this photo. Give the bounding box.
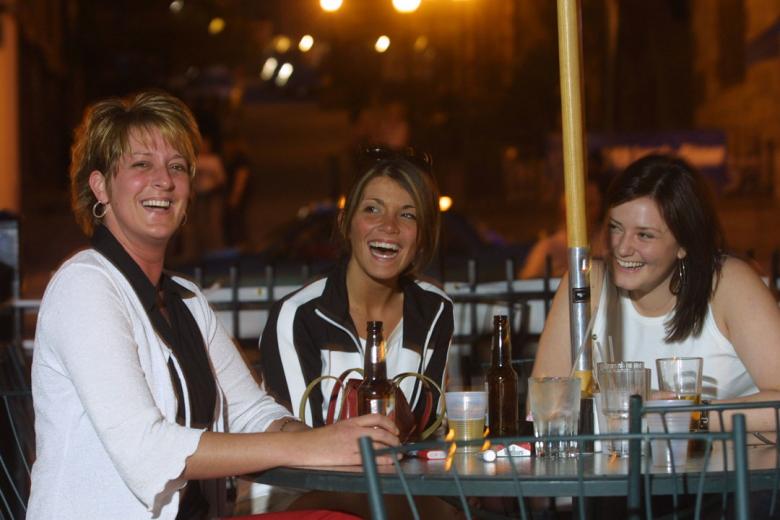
[27,91,398,520]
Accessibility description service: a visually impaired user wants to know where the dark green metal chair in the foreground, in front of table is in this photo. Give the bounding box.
[360,403,750,520]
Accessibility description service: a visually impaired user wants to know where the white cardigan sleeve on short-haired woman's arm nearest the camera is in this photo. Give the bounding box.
[36,265,203,510]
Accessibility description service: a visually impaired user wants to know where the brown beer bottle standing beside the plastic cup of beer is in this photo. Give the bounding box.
[486,316,520,437]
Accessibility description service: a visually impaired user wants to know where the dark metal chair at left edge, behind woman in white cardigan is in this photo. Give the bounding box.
[0,390,35,520]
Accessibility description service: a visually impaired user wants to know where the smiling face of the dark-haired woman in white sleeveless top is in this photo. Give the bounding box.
[609,197,685,308]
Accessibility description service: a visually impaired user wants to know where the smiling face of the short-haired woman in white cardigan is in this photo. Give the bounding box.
[89,129,190,256]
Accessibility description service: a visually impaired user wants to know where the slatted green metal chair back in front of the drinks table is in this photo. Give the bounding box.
[360,402,750,520]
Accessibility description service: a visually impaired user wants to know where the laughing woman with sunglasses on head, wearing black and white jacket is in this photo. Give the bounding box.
[260,148,453,433]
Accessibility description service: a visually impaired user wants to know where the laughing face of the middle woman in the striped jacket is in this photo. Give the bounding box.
[349,176,417,284]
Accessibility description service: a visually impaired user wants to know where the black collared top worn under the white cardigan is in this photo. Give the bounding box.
[92,226,217,520]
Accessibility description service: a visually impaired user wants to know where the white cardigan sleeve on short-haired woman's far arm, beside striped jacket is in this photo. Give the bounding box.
[193,293,290,432]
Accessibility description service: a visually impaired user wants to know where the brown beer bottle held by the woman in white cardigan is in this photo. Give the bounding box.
[357,321,395,415]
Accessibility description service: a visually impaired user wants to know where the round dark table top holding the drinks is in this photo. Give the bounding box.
[249,443,780,496]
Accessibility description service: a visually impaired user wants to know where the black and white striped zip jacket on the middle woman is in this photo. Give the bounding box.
[260,257,454,426]
